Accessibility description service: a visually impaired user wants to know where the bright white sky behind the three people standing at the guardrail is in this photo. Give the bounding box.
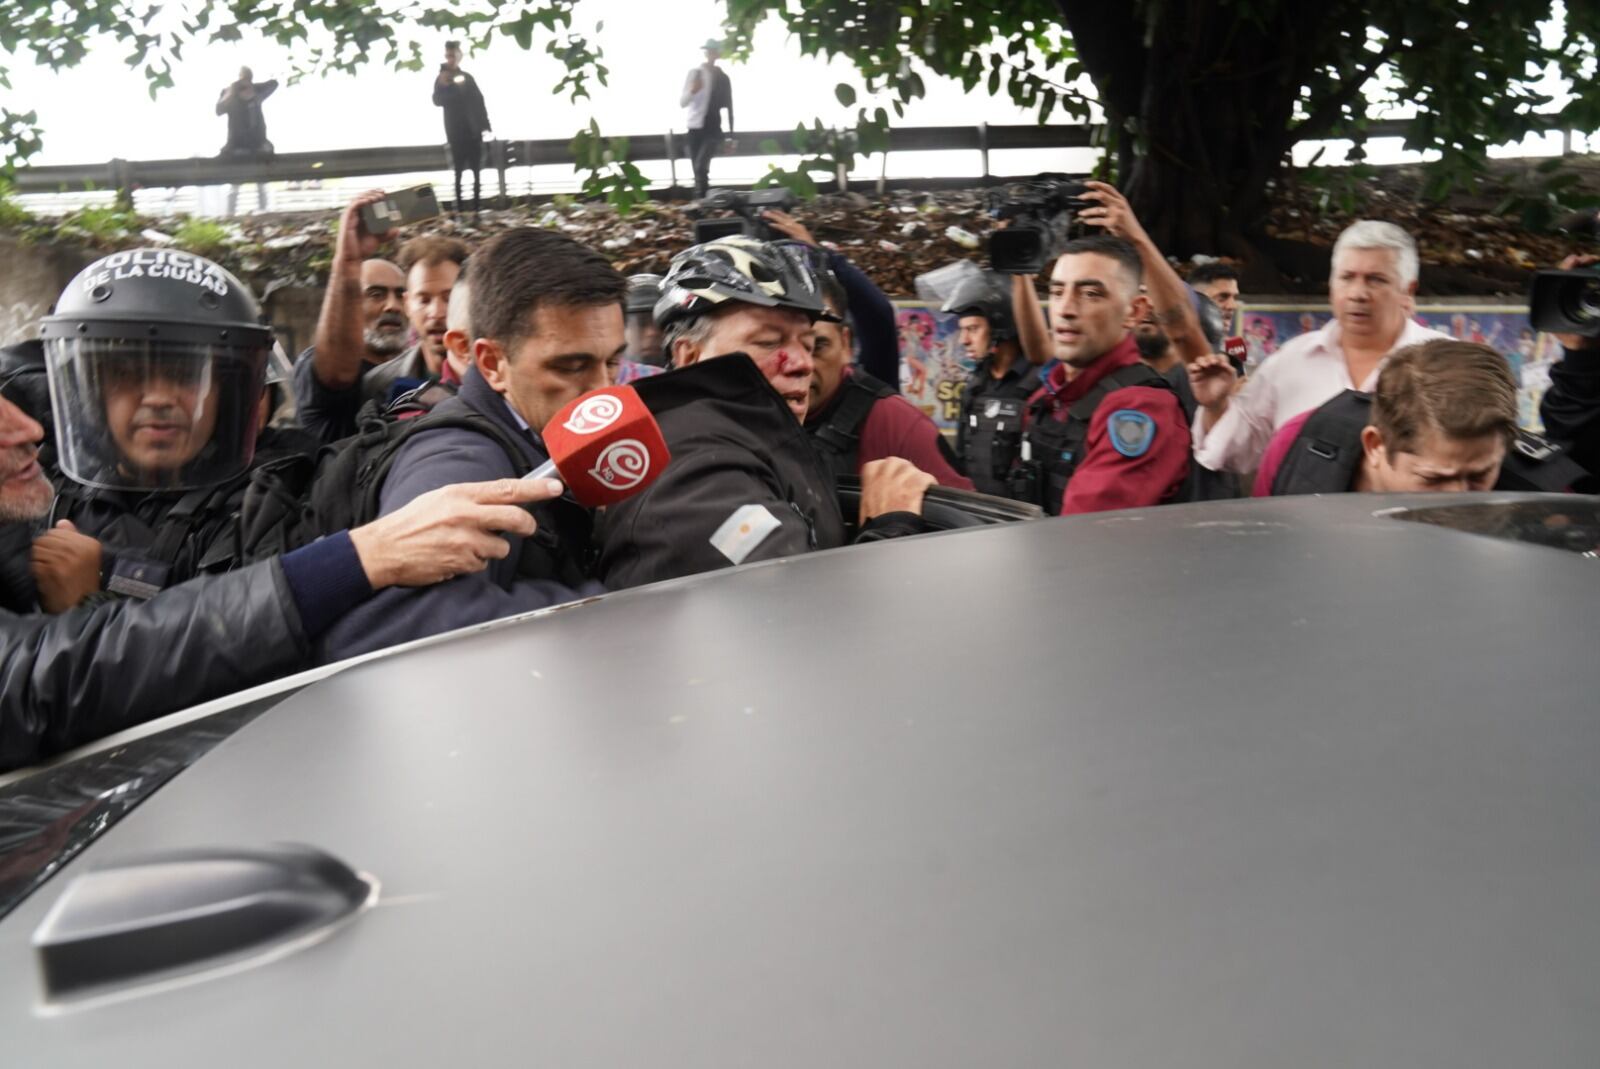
[13,0,1062,163]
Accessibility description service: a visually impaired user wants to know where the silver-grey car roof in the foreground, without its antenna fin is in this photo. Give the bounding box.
[0,494,1600,1069]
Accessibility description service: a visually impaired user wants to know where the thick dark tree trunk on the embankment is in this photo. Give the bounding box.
[1058,0,1360,290]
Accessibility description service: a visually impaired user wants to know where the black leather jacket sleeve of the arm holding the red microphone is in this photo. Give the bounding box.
[0,550,307,771]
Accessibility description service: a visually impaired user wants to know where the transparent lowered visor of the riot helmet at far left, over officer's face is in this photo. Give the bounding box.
[45,338,270,490]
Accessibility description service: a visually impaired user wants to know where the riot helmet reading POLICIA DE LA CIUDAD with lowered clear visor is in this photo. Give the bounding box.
[40,248,274,490]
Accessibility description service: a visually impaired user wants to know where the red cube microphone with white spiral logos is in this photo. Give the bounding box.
[523,386,672,509]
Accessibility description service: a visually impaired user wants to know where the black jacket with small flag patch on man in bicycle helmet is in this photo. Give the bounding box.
[600,354,923,591]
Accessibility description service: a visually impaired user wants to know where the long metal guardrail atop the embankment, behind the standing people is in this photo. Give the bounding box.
[13,118,1571,202]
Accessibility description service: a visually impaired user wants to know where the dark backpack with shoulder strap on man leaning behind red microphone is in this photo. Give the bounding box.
[240,397,536,562]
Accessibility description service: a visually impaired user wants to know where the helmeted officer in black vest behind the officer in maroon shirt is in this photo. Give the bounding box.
[941,275,1038,496]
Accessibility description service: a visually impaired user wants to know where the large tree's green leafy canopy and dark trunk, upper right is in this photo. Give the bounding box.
[725,0,1600,254]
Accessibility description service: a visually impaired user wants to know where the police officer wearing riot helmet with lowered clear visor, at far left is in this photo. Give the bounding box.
[42,250,317,597]
